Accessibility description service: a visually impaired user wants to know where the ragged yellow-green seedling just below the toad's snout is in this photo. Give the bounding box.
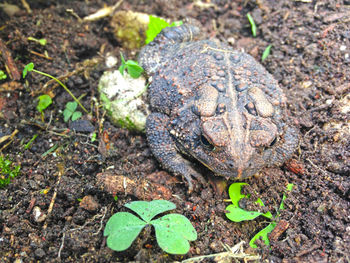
[226,183,293,248]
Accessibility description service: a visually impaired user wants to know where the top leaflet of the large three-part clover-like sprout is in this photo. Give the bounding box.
[125,200,176,223]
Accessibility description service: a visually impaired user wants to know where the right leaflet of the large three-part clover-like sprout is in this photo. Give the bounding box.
[151,214,197,255]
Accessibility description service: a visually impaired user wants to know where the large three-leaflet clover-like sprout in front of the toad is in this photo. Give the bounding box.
[104,200,197,255]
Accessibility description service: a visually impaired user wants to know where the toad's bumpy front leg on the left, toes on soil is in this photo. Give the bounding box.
[146,113,205,192]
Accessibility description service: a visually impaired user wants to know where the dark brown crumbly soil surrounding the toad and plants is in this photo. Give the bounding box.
[0,0,350,262]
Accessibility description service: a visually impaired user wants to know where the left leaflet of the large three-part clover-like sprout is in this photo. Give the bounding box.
[103,212,147,251]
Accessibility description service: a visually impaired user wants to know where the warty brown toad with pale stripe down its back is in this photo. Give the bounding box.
[139,25,298,190]
